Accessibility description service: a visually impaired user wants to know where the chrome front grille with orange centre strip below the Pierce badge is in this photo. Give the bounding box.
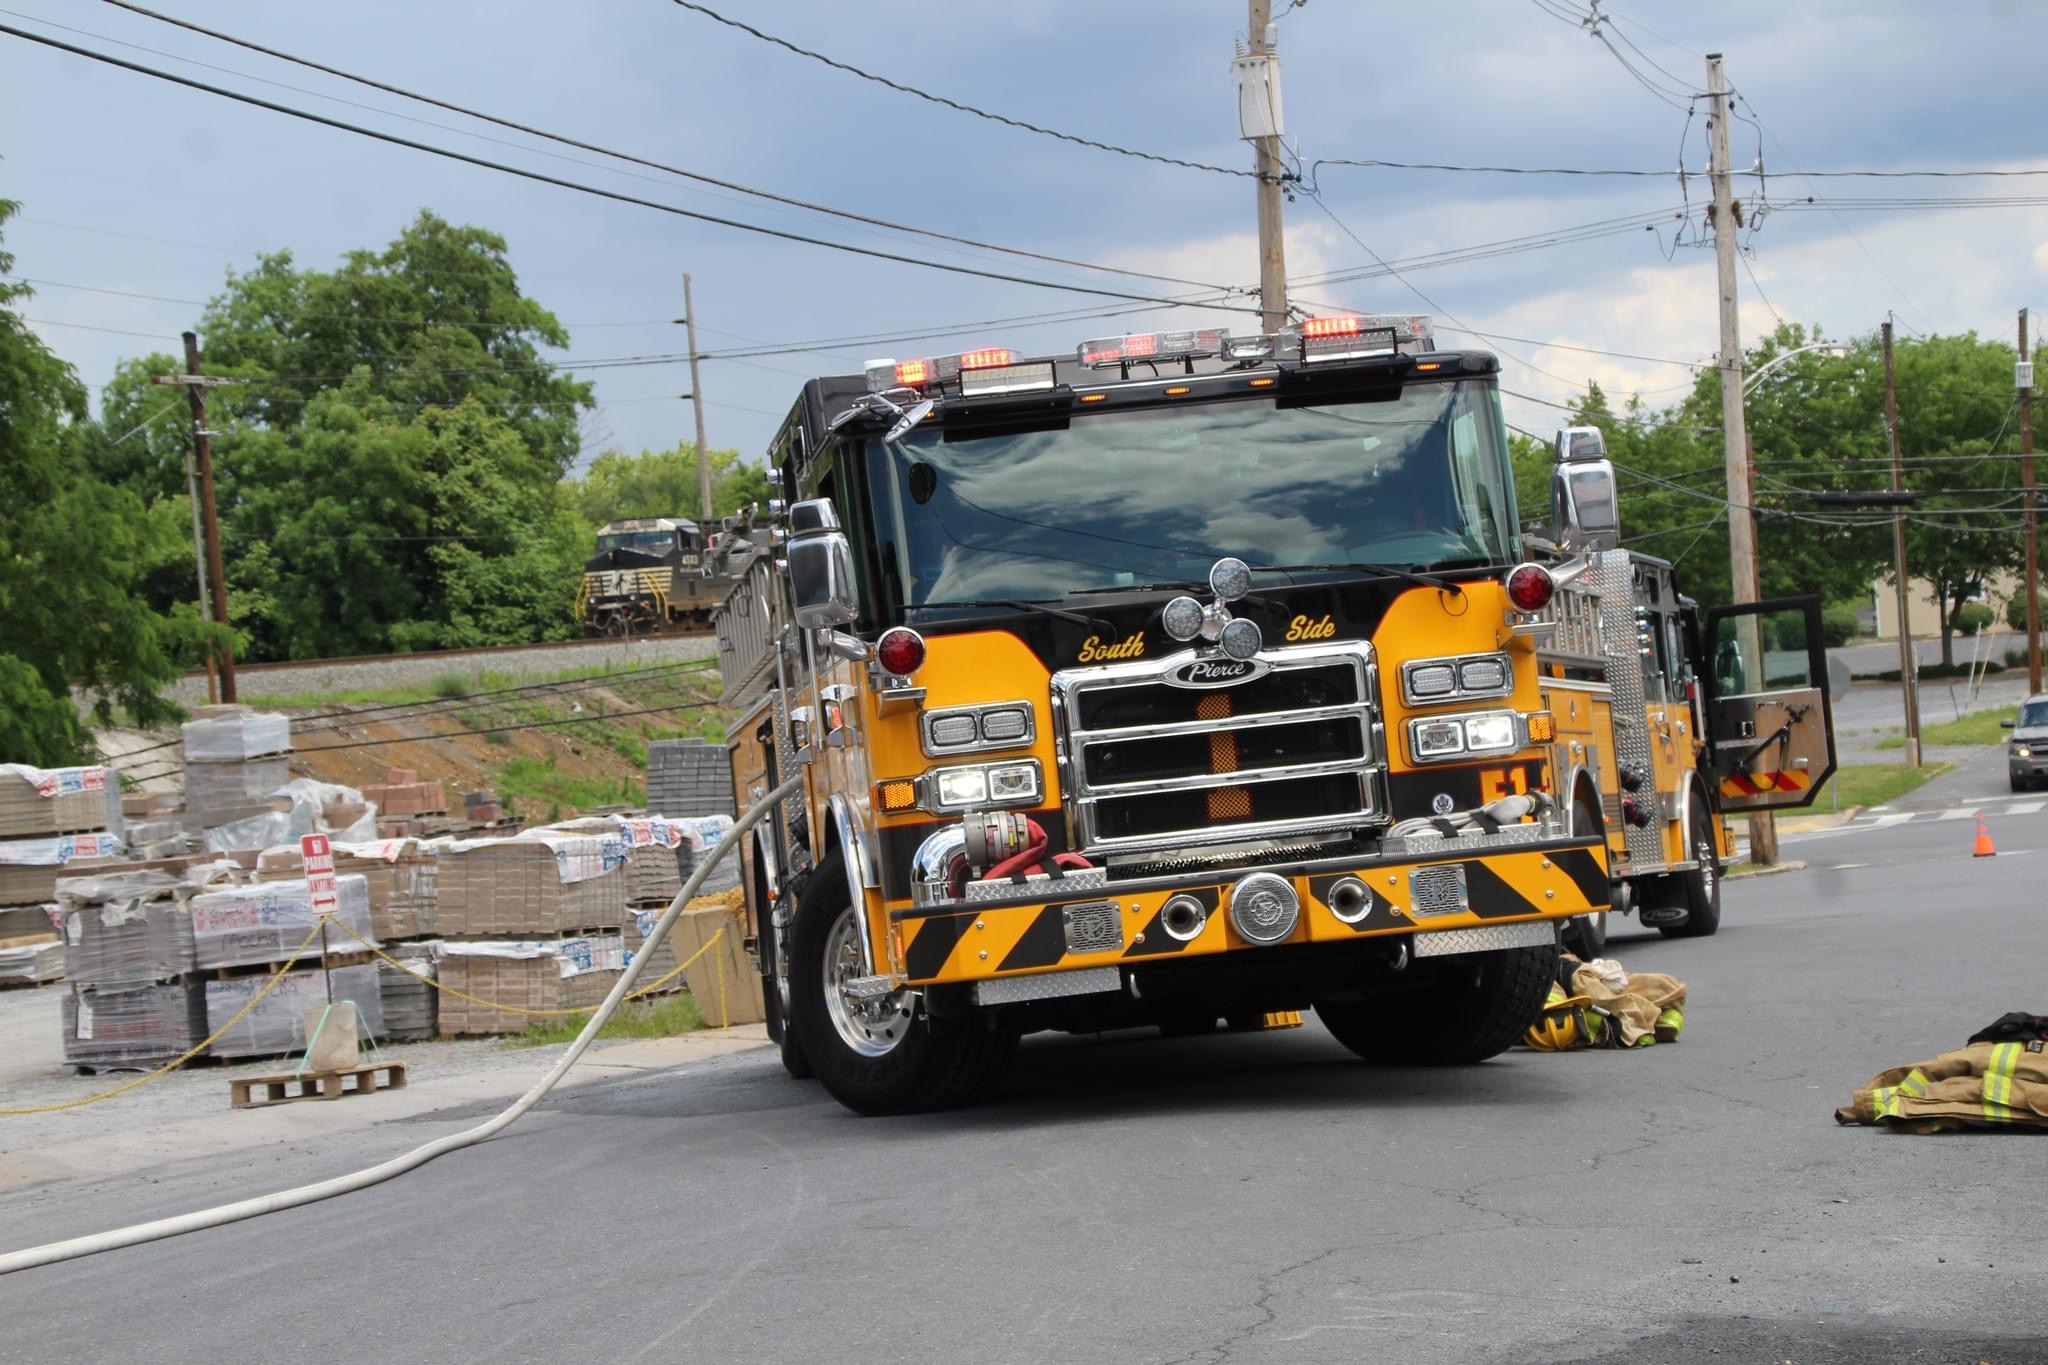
[1053,641,1384,853]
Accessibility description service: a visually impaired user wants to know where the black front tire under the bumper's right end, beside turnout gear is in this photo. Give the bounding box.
[1315,943,1556,1066]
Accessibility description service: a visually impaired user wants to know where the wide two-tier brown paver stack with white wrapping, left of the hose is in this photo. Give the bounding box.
[434,831,627,1038]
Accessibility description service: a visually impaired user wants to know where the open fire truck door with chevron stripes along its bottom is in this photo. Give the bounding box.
[1700,598,1835,810]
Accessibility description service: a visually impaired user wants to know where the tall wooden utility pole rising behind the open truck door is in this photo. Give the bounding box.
[1706,51,1778,868]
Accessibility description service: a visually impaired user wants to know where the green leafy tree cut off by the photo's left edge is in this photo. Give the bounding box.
[0,201,201,765]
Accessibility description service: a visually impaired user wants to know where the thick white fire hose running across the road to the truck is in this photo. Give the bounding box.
[0,774,803,1275]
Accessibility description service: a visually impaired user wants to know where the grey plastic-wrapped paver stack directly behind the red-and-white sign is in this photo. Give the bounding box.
[190,874,383,1056]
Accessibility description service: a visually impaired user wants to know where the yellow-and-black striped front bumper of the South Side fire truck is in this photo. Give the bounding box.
[889,837,1608,986]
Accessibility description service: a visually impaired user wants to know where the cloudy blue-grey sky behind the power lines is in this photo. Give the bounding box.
[0,0,2048,474]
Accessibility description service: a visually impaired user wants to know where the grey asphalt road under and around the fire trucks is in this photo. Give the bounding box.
[0,751,2048,1365]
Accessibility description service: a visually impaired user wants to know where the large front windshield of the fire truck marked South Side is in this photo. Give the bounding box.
[868,381,1516,608]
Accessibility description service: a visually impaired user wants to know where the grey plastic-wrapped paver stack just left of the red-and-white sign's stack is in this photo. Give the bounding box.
[57,864,233,1070]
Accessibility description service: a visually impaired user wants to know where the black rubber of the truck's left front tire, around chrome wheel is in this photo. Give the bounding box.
[788,849,1016,1115]
